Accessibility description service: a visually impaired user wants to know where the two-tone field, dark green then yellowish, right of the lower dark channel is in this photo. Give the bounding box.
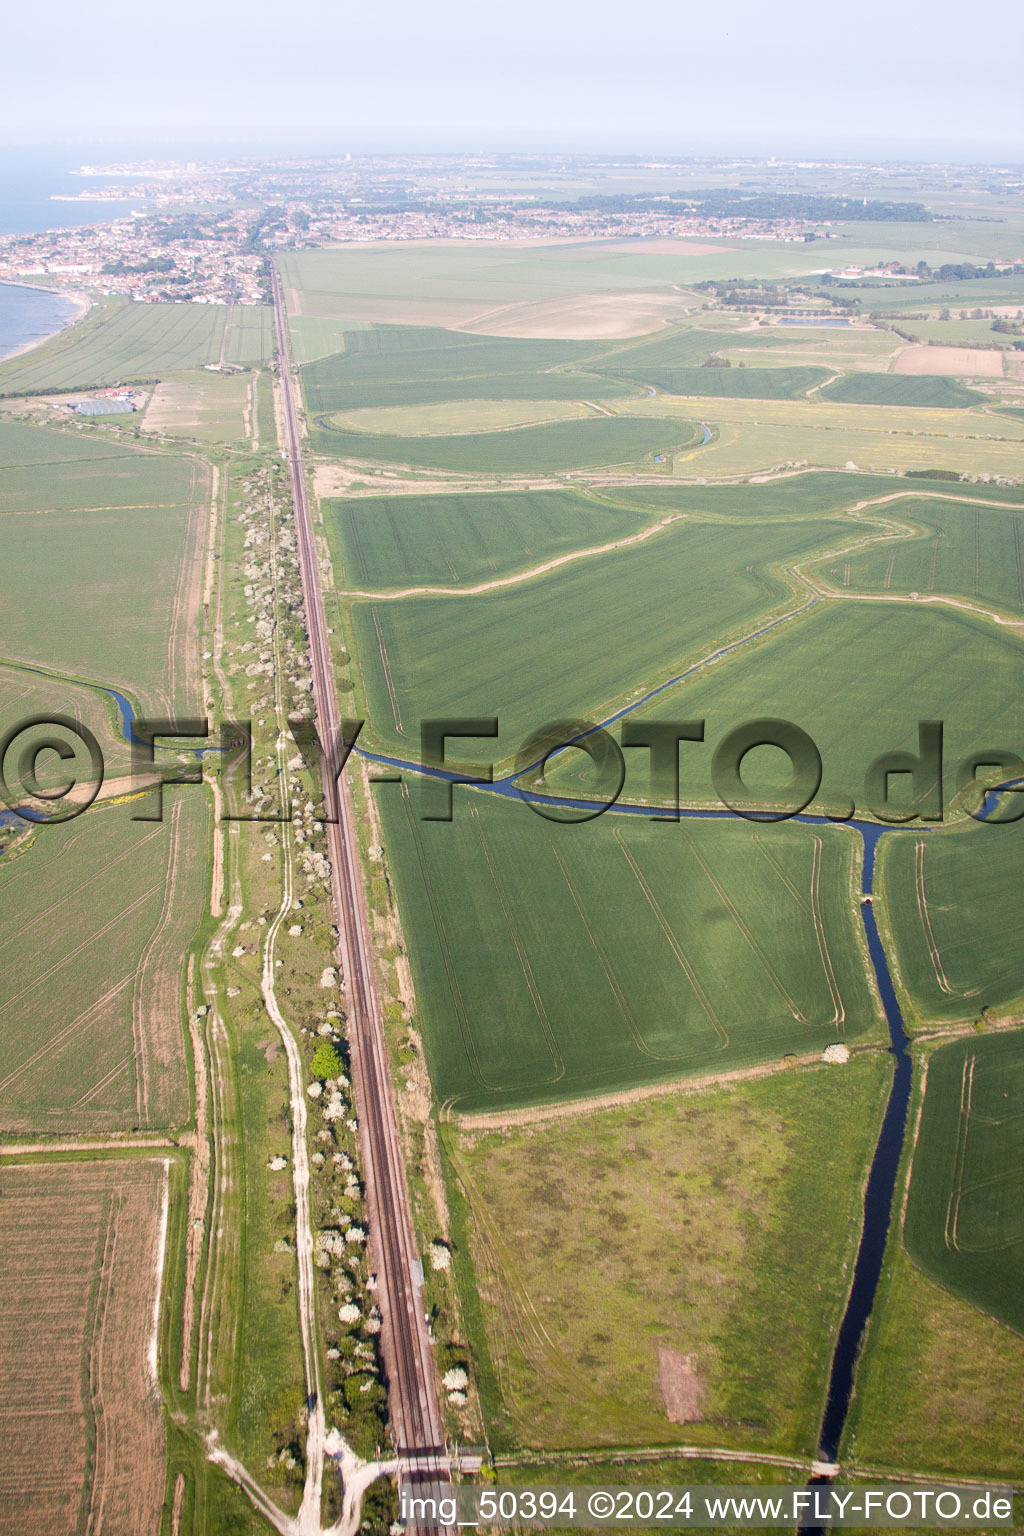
[843,1031,1024,1481]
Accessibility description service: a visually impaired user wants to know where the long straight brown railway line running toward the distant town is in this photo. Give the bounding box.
[273,272,448,1479]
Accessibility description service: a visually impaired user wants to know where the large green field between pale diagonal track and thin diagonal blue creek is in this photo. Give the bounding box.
[352,519,853,762]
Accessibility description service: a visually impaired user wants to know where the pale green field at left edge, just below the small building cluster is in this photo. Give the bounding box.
[0,421,200,513]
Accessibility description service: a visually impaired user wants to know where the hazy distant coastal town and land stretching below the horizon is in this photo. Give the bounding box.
[0,157,1024,304]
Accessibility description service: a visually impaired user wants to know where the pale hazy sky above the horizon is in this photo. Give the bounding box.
[8,0,1024,160]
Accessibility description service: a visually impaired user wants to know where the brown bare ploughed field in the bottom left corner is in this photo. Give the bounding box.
[0,1158,166,1536]
